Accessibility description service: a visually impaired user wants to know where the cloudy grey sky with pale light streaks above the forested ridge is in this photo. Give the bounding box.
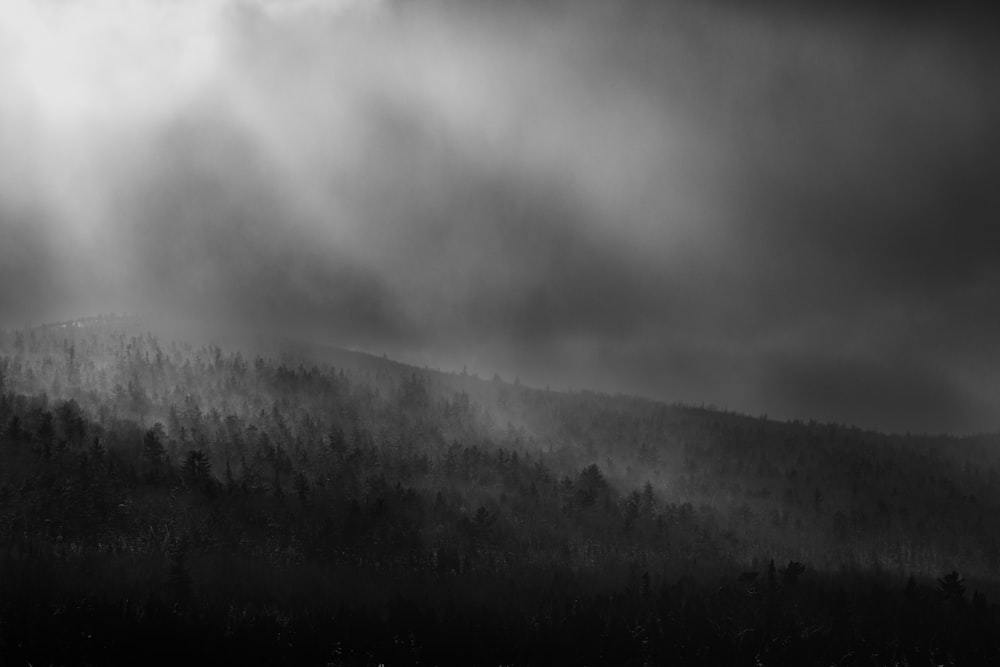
[0,0,1000,432]
